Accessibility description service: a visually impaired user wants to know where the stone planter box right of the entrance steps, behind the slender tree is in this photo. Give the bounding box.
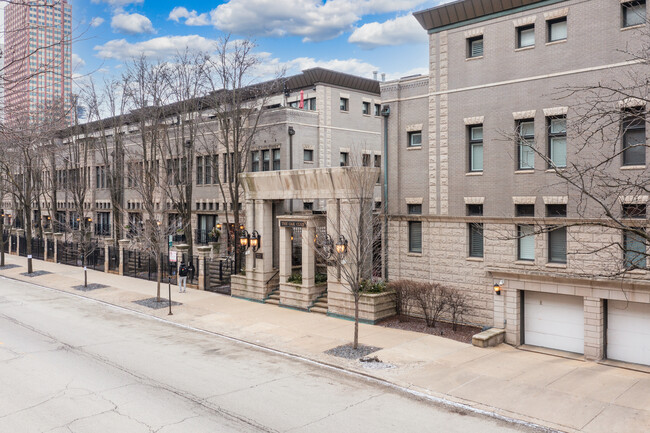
[327,283,396,324]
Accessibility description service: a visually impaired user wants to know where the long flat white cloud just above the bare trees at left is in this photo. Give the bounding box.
[95,35,216,60]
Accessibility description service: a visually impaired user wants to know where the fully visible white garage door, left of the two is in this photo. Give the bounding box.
[524,292,585,353]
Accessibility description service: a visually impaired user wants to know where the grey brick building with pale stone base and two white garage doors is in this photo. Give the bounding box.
[381,0,650,365]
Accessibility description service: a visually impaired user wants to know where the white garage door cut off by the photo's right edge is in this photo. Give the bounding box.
[607,301,650,365]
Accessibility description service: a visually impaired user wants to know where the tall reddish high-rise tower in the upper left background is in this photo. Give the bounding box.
[3,0,72,123]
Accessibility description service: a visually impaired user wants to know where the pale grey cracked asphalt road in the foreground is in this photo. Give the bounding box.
[0,277,528,433]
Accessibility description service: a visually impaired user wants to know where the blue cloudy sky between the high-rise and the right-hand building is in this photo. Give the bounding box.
[66,0,440,84]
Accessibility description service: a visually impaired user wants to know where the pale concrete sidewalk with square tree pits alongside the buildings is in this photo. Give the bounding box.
[0,256,650,433]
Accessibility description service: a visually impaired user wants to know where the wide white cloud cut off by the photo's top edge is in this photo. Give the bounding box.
[210,0,422,41]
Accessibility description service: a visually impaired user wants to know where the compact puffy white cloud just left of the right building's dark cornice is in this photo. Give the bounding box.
[348,15,427,49]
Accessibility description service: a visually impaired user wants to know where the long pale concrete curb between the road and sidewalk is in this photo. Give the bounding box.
[0,274,565,433]
